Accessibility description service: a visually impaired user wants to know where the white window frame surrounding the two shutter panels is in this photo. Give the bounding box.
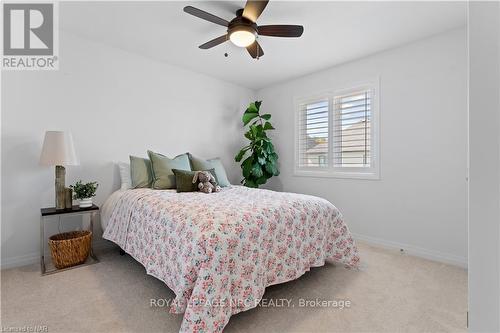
[293,77,380,180]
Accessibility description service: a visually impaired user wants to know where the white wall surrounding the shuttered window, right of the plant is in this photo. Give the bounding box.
[257,28,467,266]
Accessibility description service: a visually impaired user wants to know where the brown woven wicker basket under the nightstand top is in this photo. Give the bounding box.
[49,230,92,269]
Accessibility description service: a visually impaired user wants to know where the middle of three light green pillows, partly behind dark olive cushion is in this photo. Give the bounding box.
[148,150,191,190]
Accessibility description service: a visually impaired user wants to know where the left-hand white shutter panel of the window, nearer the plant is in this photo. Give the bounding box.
[298,98,330,168]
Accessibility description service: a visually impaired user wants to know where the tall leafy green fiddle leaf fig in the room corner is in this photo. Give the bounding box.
[235,101,279,188]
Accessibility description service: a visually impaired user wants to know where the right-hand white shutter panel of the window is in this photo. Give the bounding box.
[332,89,373,168]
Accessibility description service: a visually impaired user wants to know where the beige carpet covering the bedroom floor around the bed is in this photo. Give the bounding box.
[1,244,467,332]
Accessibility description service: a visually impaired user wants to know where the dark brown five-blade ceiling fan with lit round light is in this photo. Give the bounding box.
[184,0,304,59]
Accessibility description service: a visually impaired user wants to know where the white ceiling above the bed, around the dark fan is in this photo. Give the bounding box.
[59,0,466,89]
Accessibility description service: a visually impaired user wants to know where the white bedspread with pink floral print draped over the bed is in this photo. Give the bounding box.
[103,186,359,332]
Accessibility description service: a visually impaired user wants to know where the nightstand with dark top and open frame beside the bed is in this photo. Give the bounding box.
[40,205,99,275]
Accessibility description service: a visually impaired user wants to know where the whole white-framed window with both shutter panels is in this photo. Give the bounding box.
[295,84,379,179]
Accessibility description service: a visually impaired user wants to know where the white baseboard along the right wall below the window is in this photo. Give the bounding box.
[352,233,468,268]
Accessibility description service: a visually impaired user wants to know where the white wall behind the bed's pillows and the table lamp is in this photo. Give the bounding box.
[1,33,254,267]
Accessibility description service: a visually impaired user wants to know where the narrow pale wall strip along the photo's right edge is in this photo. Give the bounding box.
[469,2,500,332]
